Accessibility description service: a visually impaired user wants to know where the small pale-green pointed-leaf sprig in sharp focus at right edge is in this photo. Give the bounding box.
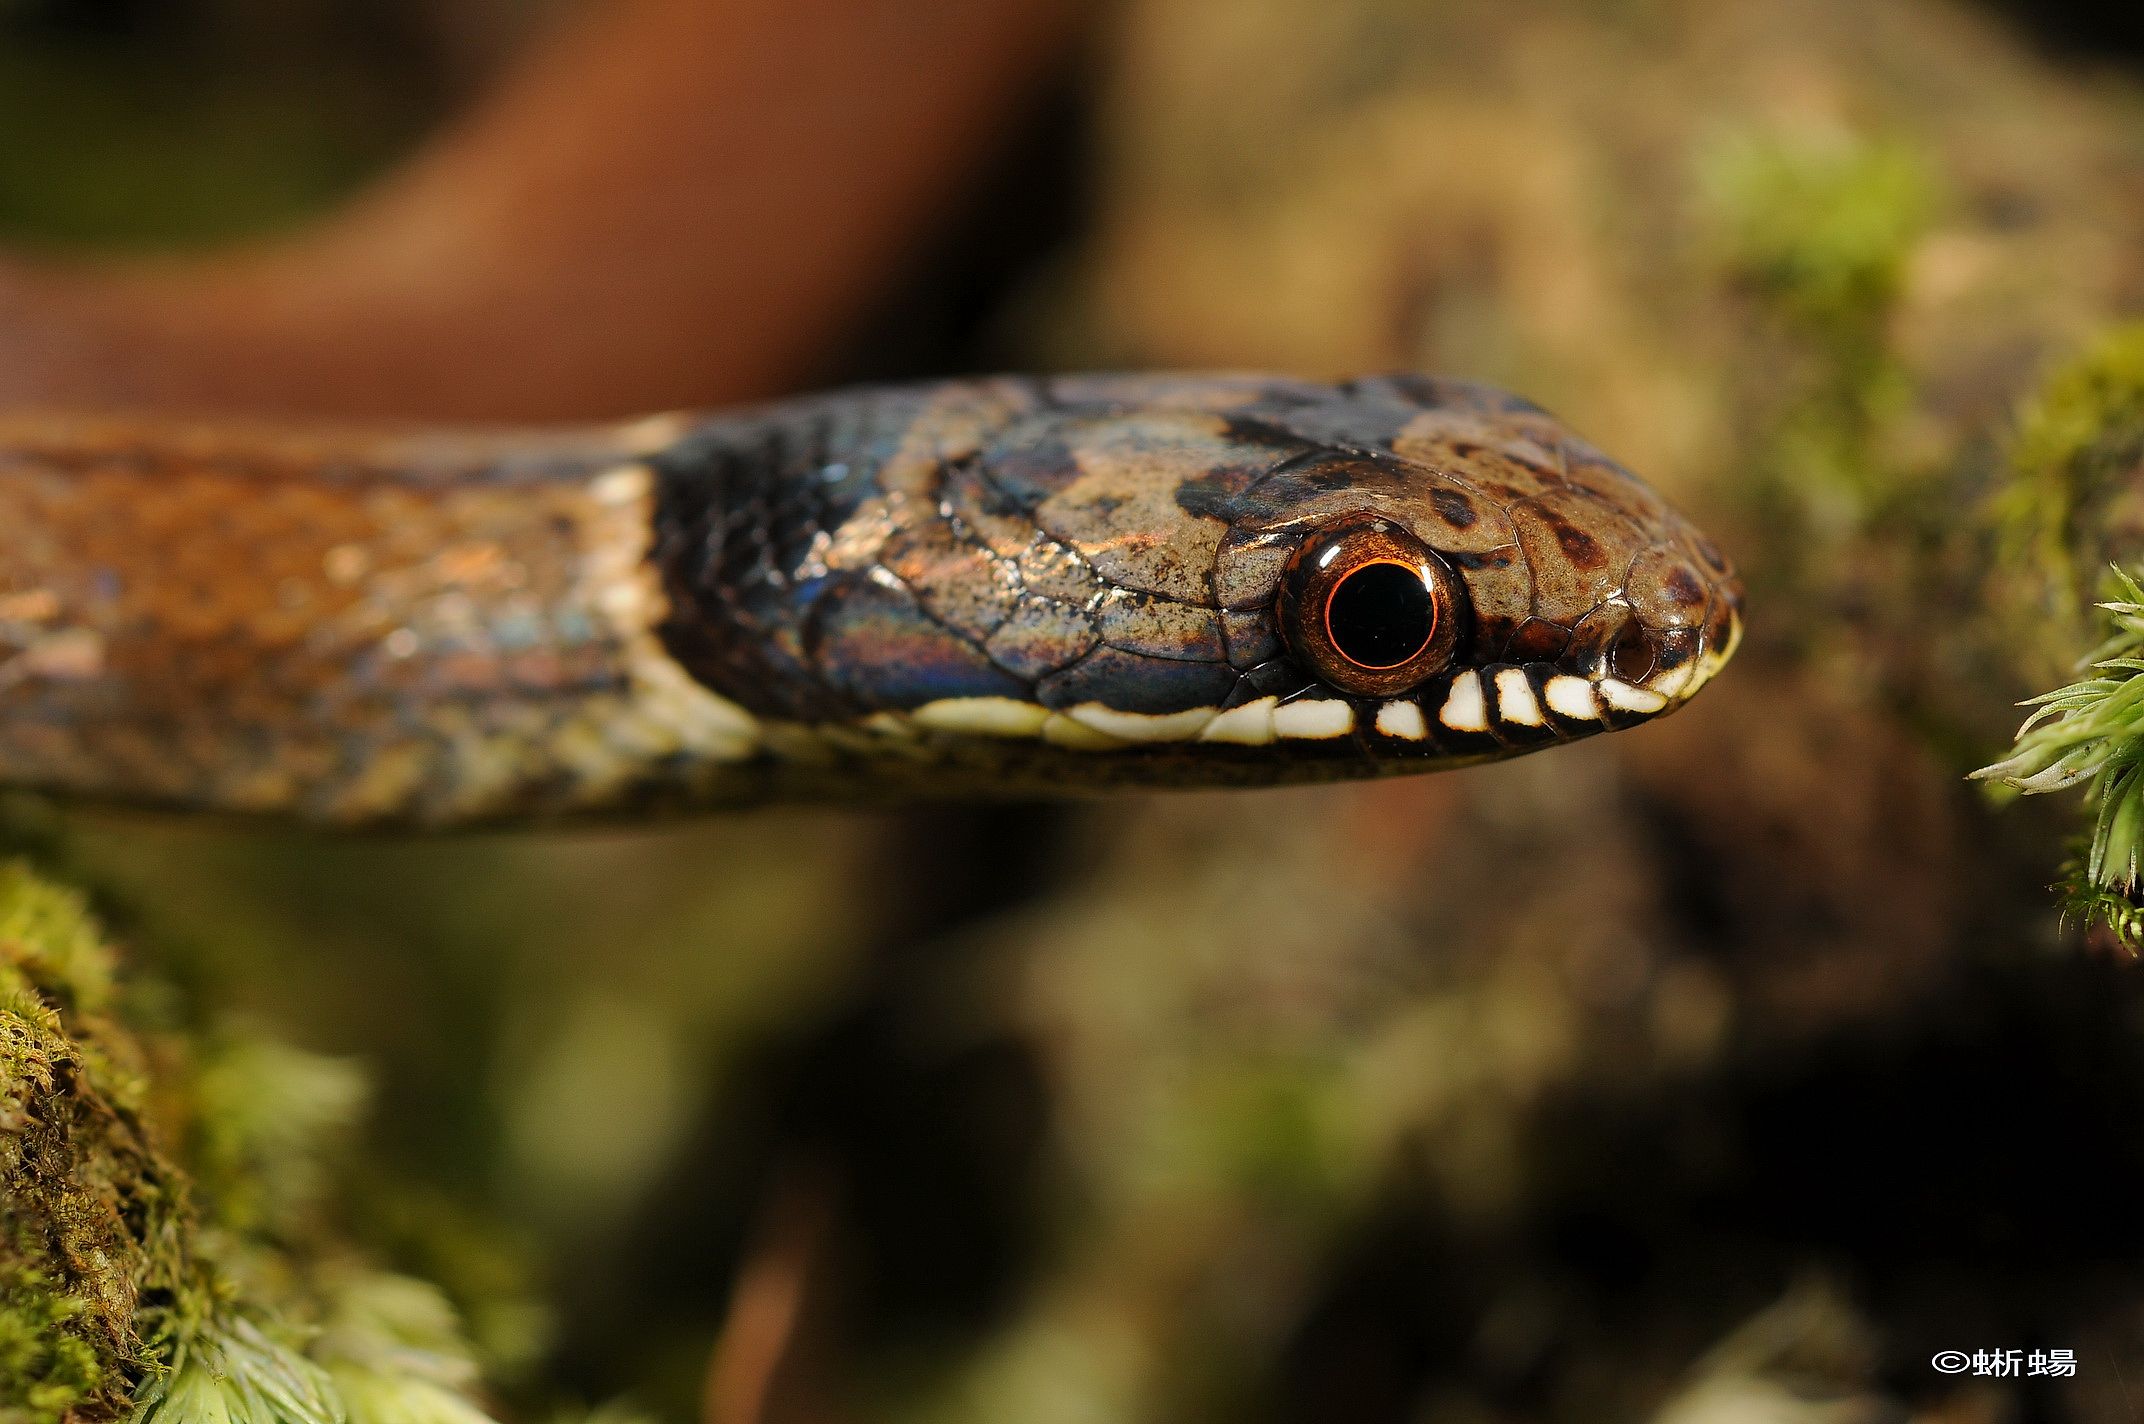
[1972,568,2144,952]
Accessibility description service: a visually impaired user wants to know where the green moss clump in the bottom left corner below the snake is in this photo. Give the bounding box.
[0,862,514,1424]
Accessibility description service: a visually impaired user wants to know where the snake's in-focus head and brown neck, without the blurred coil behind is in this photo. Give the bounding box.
[0,373,1743,826]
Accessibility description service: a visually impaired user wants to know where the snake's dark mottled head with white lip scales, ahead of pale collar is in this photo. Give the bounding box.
[658,375,1741,789]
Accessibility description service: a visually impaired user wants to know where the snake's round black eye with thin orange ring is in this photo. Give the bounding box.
[1280,515,1464,697]
